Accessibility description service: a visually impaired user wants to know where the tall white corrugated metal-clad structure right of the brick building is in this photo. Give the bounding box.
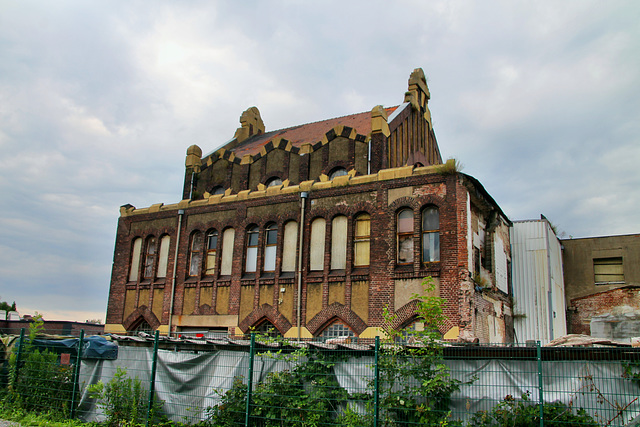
[511,217,567,343]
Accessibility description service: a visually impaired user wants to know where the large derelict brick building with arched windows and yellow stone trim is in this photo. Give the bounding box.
[105,69,513,342]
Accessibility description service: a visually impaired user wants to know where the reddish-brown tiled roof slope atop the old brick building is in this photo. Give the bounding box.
[225,106,398,157]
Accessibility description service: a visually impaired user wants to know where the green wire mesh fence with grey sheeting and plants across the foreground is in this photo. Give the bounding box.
[1,331,640,426]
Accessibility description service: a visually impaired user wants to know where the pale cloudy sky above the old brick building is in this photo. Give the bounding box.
[0,0,640,321]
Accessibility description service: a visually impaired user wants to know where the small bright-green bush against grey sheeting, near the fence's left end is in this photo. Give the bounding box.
[87,367,167,427]
